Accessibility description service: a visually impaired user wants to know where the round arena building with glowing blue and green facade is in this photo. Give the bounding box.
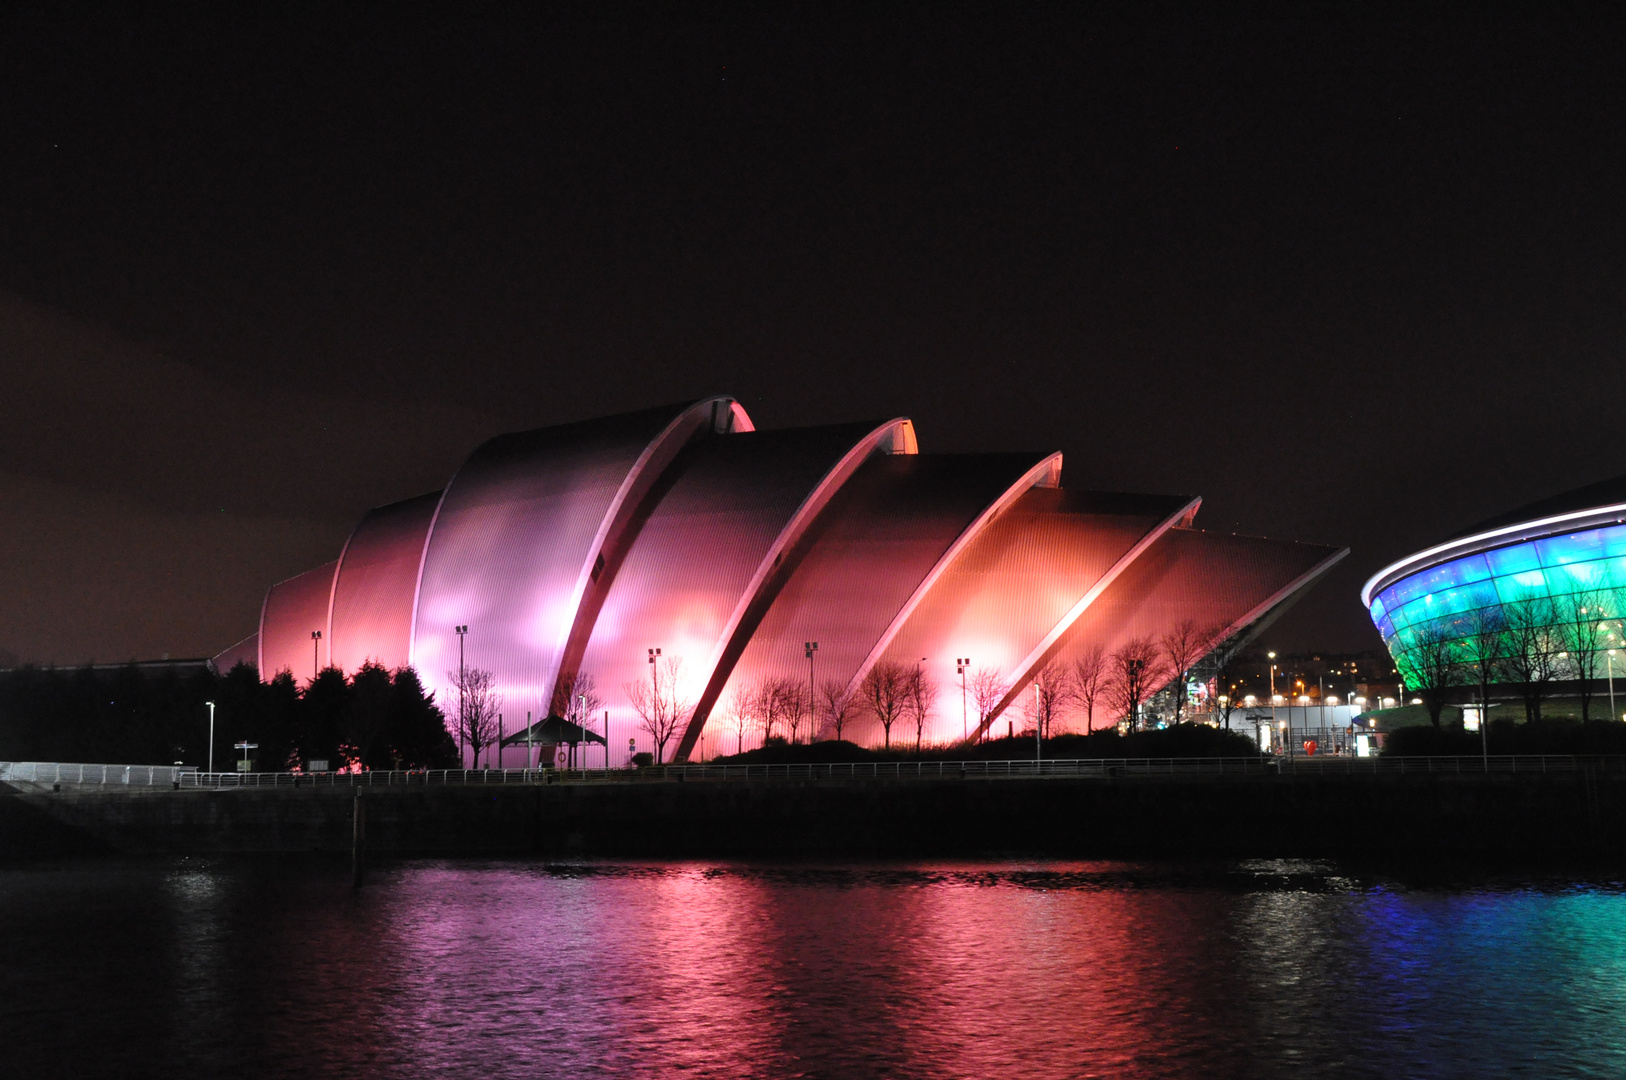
[1361,477,1626,688]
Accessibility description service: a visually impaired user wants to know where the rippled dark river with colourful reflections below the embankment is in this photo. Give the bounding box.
[0,859,1626,1078]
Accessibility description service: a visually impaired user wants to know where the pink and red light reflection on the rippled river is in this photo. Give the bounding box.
[330,865,1247,1077]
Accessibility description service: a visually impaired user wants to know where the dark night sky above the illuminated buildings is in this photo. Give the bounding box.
[0,5,1626,662]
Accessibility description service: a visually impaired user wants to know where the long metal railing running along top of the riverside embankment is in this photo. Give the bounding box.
[12,755,1626,789]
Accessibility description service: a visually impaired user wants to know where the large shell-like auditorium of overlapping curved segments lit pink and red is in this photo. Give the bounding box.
[216,397,1345,761]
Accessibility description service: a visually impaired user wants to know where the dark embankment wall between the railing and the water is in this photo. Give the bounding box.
[0,771,1626,857]
